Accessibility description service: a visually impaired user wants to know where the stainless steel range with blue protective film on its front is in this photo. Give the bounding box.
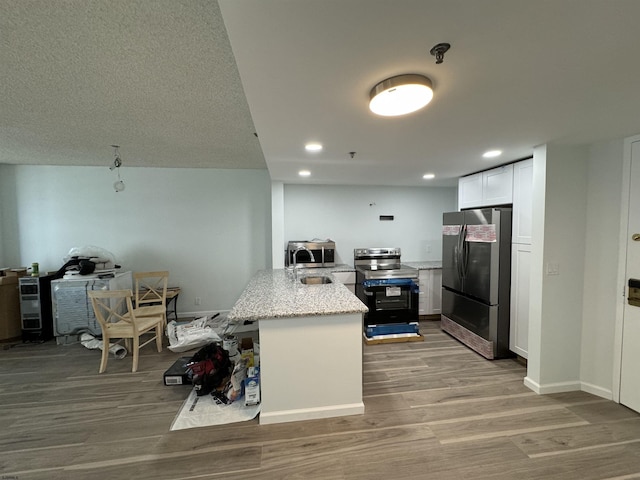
[353,248,419,333]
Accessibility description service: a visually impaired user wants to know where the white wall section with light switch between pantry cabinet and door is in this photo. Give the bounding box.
[526,145,587,393]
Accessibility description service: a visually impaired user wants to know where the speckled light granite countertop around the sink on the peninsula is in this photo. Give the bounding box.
[228,268,368,322]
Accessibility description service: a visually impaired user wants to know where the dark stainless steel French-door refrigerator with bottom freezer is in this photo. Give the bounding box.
[441,208,511,359]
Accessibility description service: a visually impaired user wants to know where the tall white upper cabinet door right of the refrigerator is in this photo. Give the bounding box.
[511,159,533,244]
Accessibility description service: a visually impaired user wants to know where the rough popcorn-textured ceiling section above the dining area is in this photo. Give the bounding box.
[0,0,266,168]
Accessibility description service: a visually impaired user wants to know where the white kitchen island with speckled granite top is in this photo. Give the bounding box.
[229,269,367,424]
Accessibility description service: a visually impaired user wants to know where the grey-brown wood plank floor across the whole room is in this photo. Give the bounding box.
[0,321,640,480]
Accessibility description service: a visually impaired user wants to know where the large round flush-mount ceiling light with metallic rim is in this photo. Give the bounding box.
[369,73,433,117]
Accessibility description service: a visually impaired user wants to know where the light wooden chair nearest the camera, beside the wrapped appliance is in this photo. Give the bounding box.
[88,290,164,373]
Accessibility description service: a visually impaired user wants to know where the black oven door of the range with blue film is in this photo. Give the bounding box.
[356,278,419,326]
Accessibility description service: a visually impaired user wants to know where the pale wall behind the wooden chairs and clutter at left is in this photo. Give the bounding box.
[0,166,271,315]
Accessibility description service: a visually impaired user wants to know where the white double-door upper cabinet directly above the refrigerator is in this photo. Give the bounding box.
[458,164,513,209]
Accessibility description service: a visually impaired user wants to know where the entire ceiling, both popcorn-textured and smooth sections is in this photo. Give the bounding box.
[0,0,640,186]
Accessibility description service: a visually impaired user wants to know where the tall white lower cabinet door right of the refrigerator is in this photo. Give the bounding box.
[509,243,531,358]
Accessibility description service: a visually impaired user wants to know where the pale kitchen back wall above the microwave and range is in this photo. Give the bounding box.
[282,185,457,265]
